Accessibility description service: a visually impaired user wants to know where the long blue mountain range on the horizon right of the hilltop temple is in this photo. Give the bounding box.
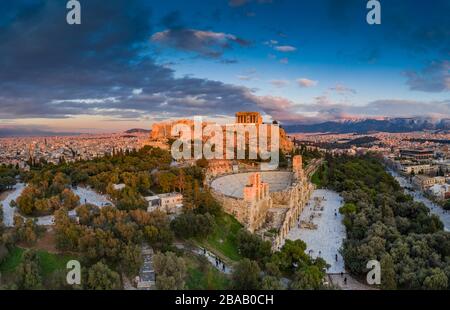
[284,118,450,134]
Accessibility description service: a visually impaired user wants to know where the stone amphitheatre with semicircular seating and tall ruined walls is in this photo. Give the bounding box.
[209,155,314,249]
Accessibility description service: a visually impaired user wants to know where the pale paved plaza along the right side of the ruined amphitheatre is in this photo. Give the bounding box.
[287,189,346,273]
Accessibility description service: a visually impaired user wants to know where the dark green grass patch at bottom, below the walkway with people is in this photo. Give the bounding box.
[184,255,230,290]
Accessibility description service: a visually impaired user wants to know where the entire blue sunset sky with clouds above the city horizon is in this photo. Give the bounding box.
[0,0,450,133]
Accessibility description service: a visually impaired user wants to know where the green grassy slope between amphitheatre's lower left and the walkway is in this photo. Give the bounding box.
[200,214,242,261]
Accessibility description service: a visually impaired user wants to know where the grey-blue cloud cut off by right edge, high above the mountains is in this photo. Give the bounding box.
[404,60,450,93]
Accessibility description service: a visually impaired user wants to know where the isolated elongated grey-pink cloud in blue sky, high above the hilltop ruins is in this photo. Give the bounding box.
[151,29,250,58]
